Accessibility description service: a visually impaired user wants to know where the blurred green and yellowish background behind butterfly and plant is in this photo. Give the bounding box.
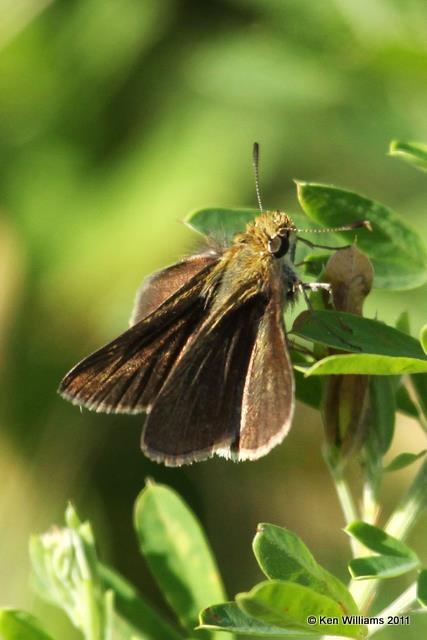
[0,0,427,639]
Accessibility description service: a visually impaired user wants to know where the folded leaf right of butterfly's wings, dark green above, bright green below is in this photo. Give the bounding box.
[290,310,427,375]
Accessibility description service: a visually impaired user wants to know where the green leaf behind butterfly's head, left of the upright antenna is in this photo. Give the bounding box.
[184,207,259,243]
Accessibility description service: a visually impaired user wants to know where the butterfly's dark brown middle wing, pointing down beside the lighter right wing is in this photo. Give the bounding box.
[141,294,266,466]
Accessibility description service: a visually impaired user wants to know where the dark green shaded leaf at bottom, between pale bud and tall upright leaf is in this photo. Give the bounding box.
[99,564,182,640]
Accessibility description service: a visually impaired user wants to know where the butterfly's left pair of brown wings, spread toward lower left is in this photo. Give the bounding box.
[59,257,217,413]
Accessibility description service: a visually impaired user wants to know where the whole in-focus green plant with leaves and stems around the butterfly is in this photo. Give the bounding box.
[0,142,427,640]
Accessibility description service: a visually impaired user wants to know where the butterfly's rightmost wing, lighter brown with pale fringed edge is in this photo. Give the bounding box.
[237,298,294,460]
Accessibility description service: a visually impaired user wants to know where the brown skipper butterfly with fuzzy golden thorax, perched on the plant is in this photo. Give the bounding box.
[59,144,370,466]
